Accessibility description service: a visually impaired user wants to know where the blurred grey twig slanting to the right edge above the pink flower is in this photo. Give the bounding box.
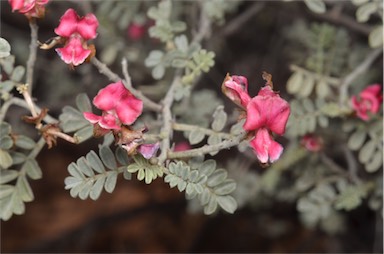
[339,48,383,106]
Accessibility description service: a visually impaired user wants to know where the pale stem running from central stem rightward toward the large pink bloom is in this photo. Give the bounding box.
[168,134,245,159]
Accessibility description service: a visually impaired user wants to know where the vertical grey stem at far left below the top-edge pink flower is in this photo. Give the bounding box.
[26,18,39,94]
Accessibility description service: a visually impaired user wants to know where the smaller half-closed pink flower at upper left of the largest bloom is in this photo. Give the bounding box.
[221,74,251,108]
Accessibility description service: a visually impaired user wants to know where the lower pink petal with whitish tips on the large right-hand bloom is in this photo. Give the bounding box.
[250,128,283,163]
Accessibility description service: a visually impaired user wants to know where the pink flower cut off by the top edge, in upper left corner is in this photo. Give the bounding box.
[8,0,49,18]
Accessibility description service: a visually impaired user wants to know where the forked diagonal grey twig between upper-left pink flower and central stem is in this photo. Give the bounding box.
[91,57,161,112]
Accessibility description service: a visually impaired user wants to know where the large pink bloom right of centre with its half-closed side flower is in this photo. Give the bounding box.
[222,75,290,164]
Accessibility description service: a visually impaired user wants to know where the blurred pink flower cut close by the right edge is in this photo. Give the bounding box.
[351,84,383,121]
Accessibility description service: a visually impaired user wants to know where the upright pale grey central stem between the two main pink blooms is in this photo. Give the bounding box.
[158,72,181,165]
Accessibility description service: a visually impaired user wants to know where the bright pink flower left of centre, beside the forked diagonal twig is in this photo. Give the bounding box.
[83,81,143,129]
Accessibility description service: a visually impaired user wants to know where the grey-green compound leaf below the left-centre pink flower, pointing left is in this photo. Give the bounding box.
[64,146,127,200]
